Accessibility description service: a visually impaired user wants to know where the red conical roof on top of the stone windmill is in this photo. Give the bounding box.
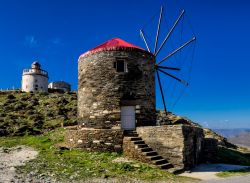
[80,38,145,58]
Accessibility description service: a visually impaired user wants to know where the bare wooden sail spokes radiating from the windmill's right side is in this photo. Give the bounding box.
[140,6,196,114]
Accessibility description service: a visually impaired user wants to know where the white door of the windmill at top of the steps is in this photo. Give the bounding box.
[121,106,135,130]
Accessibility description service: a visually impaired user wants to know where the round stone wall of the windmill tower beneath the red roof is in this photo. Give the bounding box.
[78,50,156,128]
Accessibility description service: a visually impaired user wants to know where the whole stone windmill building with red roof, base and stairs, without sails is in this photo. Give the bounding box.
[65,38,220,171]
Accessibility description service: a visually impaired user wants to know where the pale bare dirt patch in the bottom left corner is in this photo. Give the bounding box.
[0,146,38,183]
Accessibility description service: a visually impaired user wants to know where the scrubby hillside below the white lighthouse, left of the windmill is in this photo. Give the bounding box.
[0,91,77,136]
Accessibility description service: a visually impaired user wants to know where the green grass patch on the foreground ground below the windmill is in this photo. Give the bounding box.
[0,129,193,182]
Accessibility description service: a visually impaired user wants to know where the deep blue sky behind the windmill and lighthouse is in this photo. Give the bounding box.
[0,0,250,128]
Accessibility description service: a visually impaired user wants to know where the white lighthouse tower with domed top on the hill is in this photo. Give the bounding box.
[22,61,49,92]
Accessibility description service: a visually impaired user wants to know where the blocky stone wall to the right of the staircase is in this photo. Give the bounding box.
[136,125,204,170]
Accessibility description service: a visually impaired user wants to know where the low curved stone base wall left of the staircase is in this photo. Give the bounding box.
[65,128,123,152]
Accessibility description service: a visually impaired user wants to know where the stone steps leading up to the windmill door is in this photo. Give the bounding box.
[124,131,174,170]
